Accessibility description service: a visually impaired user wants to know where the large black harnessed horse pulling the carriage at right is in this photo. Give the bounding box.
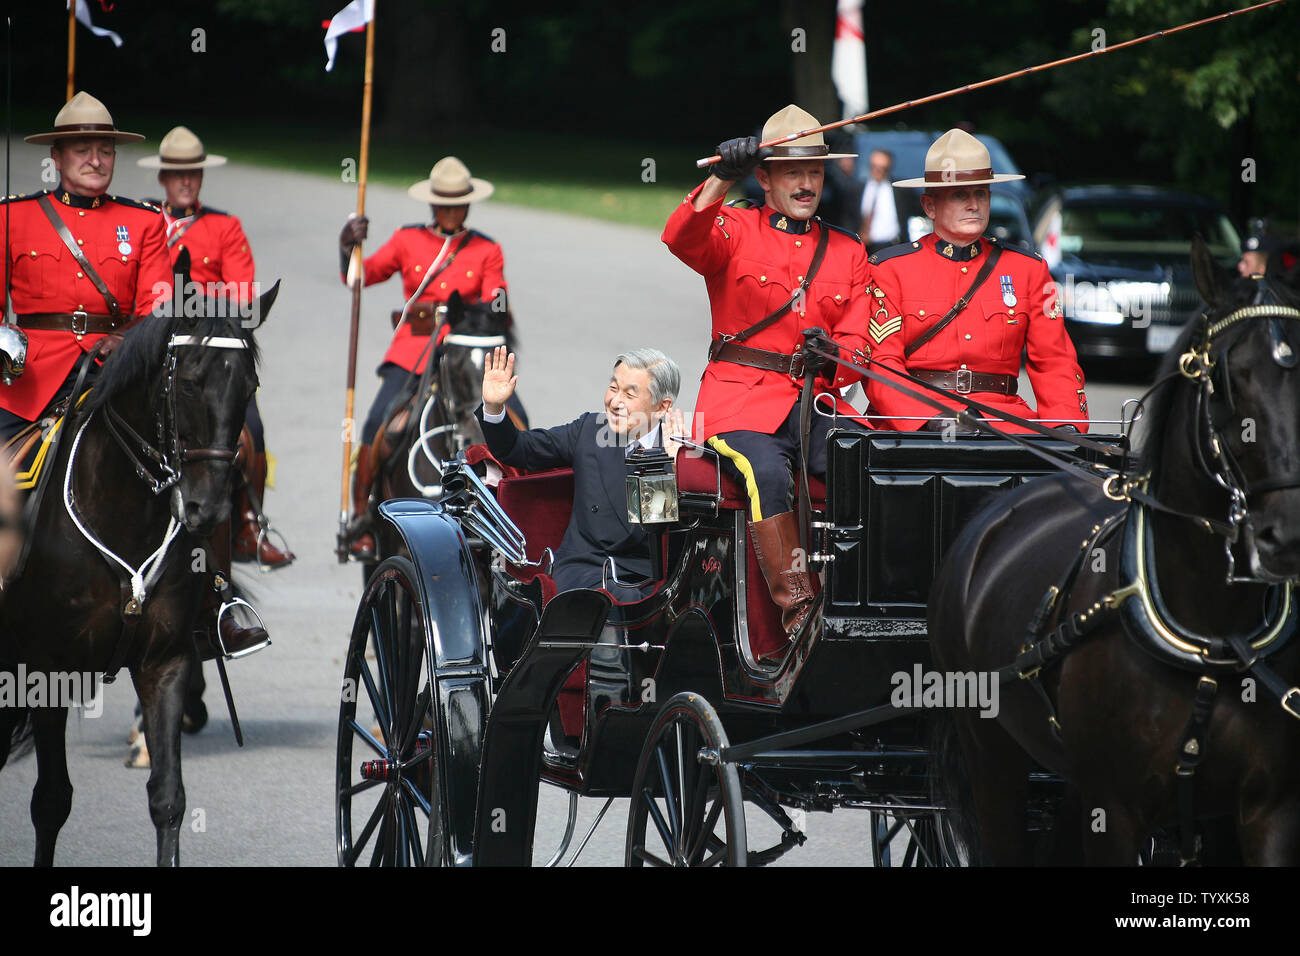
[930,241,1300,865]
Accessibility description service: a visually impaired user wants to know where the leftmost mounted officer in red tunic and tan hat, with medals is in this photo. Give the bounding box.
[0,92,267,671]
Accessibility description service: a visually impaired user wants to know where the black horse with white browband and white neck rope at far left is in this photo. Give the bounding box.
[0,274,278,866]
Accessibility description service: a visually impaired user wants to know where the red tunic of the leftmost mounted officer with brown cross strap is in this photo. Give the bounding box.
[0,190,172,421]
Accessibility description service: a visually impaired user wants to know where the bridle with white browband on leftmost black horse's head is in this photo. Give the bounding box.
[104,334,248,494]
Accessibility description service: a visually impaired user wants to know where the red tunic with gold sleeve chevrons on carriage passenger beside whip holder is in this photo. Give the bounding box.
[867,234,1088,432]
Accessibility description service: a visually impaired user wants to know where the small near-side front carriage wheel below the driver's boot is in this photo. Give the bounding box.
[624,693,746,866]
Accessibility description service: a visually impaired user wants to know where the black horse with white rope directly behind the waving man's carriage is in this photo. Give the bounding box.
[367,293,528,567]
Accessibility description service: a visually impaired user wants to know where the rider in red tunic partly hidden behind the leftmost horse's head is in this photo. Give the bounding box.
[137,126,294,570]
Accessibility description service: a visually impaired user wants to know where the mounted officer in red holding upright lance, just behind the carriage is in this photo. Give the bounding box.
[339,156,507,561]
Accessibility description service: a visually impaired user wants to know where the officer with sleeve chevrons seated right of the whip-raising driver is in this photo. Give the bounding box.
[867,129,1088,431]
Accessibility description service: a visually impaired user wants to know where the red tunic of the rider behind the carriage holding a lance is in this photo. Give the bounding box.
[351,224,506,372]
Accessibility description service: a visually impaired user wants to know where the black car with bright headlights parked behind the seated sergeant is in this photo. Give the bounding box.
[1034,186,1242,359]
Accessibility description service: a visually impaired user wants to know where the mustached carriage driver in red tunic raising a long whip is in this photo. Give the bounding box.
[663,105,870,654]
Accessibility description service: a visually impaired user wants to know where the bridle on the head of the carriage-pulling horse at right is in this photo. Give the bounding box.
[1178,286,1300,581]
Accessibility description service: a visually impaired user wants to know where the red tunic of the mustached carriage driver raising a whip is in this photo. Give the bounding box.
[662,183,871,440]
